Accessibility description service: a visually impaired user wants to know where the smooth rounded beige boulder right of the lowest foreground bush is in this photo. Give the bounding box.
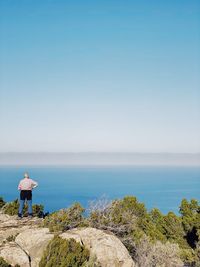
[60,228,135,267]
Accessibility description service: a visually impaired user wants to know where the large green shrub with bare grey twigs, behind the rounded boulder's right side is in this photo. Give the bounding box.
[88,196,165,242]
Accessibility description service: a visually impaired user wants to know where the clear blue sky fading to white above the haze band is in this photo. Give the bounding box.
[0,0,200,152]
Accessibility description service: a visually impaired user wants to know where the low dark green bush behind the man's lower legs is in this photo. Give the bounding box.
[3,199,44,216]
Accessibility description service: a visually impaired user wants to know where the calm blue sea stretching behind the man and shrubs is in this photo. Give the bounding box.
[0,167,200,213]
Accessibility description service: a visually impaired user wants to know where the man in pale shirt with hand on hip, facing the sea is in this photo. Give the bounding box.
[18,172,38,218]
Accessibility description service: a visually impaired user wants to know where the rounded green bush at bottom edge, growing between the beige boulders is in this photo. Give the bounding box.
[39,236,90,267]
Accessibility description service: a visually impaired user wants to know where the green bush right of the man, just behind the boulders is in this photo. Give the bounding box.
[43,203,85,232]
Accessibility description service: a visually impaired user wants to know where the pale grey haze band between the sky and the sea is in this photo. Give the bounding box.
[0,152,200,167]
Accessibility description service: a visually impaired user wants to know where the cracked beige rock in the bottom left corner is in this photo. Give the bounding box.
[0,214,49,267]
